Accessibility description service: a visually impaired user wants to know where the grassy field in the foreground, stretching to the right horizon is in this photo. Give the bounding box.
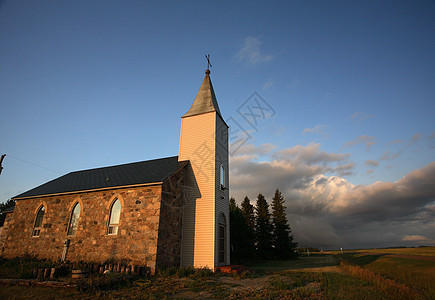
[0,248,435,300]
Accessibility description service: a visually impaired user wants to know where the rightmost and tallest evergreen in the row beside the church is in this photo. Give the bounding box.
[272,189,297,259]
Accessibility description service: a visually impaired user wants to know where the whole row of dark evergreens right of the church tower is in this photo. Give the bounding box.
[230,189,297,263]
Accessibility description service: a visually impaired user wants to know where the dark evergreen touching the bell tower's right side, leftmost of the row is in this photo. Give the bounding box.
[230,198,251,263]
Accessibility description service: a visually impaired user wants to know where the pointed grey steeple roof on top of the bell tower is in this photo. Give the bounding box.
[182,70,222,118]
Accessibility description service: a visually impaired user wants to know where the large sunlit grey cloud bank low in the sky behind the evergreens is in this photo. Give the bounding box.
[230,143,435,249]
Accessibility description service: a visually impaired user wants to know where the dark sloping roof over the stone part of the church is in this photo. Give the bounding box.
[13,156,186,199]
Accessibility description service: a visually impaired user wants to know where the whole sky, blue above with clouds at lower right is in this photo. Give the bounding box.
[0,0,435,247]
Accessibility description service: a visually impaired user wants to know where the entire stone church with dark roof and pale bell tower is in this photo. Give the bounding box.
[1,69,230,273]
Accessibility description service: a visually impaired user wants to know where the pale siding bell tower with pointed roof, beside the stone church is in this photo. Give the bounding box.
[178,69,230,269]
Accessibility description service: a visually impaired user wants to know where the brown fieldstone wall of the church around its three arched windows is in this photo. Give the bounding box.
[3,178,182,273]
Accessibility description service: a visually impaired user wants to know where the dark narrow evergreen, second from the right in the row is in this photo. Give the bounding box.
[255,194,272,258]
